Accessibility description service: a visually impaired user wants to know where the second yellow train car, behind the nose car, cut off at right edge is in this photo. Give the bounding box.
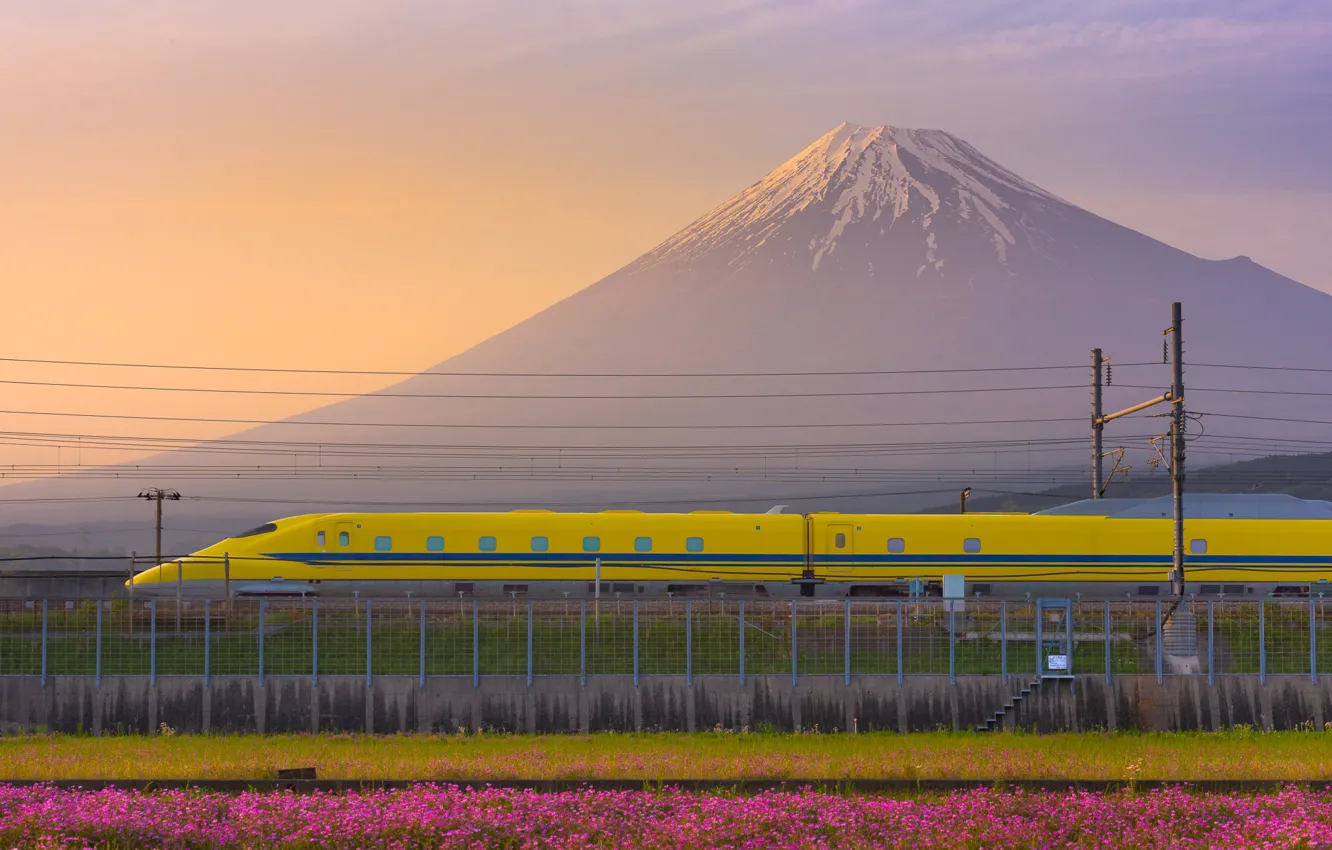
[809,494,1332,598]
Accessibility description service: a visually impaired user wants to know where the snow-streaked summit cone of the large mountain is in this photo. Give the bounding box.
[630,124,1067,277]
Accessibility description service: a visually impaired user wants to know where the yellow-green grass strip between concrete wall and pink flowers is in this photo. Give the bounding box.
[0,730,1332,781]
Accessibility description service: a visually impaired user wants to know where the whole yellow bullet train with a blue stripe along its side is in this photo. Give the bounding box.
[127,494,1332,600]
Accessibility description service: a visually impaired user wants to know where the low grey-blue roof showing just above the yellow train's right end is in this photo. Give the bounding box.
[1036,493,1332,520]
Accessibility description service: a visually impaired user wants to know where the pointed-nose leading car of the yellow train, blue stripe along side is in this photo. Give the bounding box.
[131,510,805,598]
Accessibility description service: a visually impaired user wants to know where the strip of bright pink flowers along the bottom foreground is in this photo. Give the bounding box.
[0,785,1332,849]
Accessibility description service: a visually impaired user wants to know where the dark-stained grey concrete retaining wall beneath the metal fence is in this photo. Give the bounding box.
[0,675,1332,734]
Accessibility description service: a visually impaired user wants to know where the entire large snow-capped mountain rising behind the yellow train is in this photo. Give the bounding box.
[7,124,1332,538]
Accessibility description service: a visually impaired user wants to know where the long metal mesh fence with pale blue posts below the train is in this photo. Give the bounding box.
[0,598,1332,683]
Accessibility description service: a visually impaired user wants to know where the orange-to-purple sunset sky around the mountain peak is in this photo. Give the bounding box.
[0,0,1332,474]
